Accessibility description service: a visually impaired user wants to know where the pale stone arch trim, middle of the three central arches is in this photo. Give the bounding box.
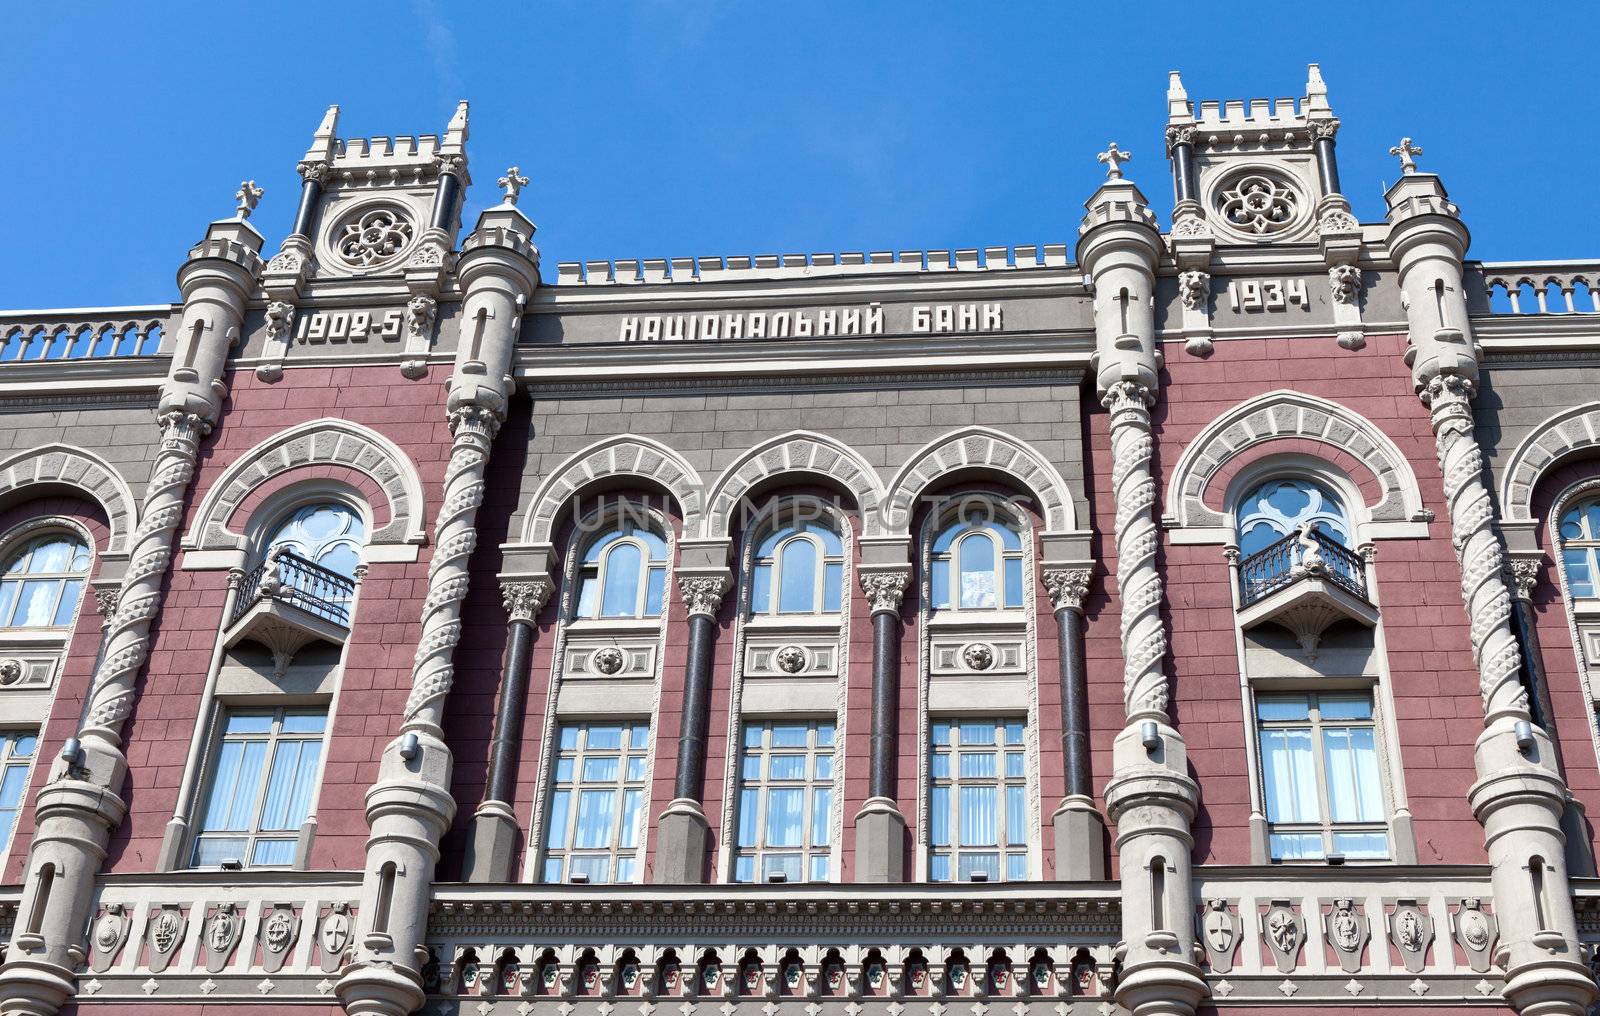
[701,430,883,539]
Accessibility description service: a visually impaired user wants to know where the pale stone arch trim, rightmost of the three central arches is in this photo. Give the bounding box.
[883,427,1077,536]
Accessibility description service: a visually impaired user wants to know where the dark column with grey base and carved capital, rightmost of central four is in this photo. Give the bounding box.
[1045,568,1106,882]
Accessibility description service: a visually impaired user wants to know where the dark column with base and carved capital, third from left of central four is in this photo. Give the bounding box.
[854,566,910,882]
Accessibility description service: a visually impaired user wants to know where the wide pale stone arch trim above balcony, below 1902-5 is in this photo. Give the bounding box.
[182,418,424,553]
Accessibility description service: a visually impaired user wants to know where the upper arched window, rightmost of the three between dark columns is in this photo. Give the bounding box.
[930,504,1022,611]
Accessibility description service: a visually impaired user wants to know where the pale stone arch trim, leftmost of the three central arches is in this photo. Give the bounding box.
[522,434,704,546]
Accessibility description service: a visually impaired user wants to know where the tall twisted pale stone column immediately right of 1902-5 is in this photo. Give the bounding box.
[334,187,539,1016]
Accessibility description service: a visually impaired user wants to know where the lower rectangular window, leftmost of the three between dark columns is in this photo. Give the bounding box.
[542,723,650,883]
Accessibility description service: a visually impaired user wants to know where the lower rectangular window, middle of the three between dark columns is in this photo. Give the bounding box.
[733,722,834,882]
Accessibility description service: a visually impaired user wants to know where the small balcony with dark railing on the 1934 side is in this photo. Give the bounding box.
[1238,526,1378,661]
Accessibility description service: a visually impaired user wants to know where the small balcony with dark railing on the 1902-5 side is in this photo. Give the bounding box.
[226,547,355,678]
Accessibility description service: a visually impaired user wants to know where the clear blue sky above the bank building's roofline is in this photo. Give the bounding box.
[0,0,1600,307]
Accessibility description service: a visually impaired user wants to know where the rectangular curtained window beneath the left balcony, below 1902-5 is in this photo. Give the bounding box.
[192,709,328,867]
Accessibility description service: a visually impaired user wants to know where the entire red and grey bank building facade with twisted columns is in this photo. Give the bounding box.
[0,67,1600,1016]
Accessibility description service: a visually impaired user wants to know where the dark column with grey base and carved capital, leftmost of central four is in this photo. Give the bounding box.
[466,576,554,882]
